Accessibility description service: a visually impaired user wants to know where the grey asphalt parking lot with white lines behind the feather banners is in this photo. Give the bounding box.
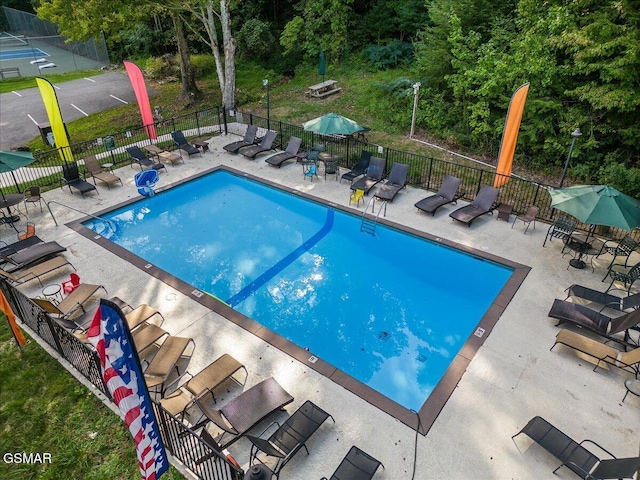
[0,72,154,150]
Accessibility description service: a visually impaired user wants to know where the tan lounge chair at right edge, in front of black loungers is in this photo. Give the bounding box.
[549,329,640,377]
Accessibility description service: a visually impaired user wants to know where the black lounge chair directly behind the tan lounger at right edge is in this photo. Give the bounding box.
[549,299,640,345]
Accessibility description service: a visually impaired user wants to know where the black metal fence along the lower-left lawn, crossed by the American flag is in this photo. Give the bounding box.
[0,279,244,480]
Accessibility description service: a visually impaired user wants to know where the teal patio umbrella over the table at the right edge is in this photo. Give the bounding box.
[549,185,640,230]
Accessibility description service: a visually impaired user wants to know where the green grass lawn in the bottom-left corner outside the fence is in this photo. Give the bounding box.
[0,318,183,480]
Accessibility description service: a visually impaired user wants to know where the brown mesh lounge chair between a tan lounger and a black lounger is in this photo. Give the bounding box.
[193,377,293,448]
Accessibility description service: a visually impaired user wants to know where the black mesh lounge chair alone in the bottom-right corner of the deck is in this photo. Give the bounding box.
[511,417,640,480]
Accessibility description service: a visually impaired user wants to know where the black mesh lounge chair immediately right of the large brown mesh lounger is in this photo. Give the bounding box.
[246,400,335,478]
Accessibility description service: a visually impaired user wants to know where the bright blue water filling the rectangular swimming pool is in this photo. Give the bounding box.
[85,172,512,410]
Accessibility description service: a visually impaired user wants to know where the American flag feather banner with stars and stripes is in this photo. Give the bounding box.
[87,299,169,480]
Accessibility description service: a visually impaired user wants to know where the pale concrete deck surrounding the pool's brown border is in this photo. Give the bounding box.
[7,135,640,479]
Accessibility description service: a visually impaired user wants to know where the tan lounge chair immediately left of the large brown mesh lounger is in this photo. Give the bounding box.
[160,353,249,416]
